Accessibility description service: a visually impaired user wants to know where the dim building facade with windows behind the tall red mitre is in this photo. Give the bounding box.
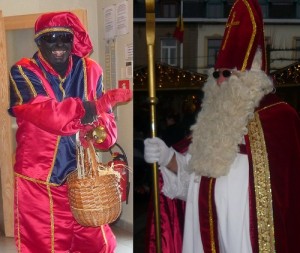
[134,0,300,74]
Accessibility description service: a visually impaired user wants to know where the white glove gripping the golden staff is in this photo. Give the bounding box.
[144,137,174,167]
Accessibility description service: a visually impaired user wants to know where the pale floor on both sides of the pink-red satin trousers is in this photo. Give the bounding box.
[0,225,133,253]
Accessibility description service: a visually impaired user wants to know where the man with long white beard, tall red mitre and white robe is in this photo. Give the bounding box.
[145,0,300,253]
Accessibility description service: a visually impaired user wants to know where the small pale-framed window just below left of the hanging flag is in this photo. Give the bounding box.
[160,38,177,66]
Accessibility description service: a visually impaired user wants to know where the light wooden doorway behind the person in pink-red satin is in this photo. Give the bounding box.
[0,9,87,237]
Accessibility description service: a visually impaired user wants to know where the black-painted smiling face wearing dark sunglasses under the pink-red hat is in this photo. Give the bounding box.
[37,32,73,75]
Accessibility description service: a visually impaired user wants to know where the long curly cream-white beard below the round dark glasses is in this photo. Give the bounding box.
[189,70,273,178]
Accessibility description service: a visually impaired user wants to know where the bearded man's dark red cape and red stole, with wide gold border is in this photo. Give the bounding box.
[146,94,300,253]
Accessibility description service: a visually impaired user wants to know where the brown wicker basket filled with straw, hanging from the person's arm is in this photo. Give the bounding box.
[67,141,122,227]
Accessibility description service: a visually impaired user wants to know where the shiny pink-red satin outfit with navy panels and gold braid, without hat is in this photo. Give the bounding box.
[9,53,116,253]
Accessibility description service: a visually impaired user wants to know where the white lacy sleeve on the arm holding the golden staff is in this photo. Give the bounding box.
[160,152,191,200]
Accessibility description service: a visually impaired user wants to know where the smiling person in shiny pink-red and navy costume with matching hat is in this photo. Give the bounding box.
[9,12,132,253]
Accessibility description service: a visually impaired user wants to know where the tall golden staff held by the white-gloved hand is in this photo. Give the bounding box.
[145,0,161,253]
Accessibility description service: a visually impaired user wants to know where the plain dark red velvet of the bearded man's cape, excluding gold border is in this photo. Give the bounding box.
[247,94,300,253]
